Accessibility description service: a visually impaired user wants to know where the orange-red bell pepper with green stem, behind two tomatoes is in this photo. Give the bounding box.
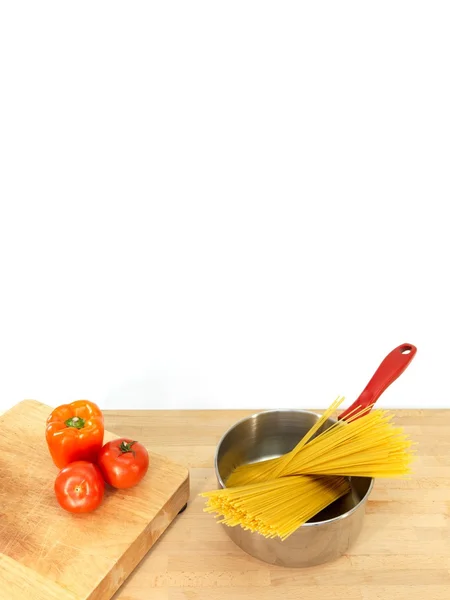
[45,400,104,469]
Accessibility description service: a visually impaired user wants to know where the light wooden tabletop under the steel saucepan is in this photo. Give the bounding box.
[105,410,450,600]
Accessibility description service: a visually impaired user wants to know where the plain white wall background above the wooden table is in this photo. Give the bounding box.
[0,0,450,409]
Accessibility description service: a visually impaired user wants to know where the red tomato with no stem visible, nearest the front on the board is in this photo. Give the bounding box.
[54,460,105,513]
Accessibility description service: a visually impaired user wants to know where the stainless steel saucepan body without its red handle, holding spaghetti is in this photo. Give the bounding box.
[215,410,373,567]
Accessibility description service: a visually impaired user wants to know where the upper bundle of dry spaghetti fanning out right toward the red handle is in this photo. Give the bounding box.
[226,398,413,487]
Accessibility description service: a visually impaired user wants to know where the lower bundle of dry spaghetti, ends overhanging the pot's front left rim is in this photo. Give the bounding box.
[200,475,350,540]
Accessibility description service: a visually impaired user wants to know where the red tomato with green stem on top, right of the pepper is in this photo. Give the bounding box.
[97,438,149,489]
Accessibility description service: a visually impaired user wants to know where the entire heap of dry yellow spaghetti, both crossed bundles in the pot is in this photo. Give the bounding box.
[201,397,413,540]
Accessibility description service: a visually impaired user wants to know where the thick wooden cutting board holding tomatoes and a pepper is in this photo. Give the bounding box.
[0,400,189,600]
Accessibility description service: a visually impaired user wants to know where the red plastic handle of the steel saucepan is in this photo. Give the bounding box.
[339,344,417,420]
